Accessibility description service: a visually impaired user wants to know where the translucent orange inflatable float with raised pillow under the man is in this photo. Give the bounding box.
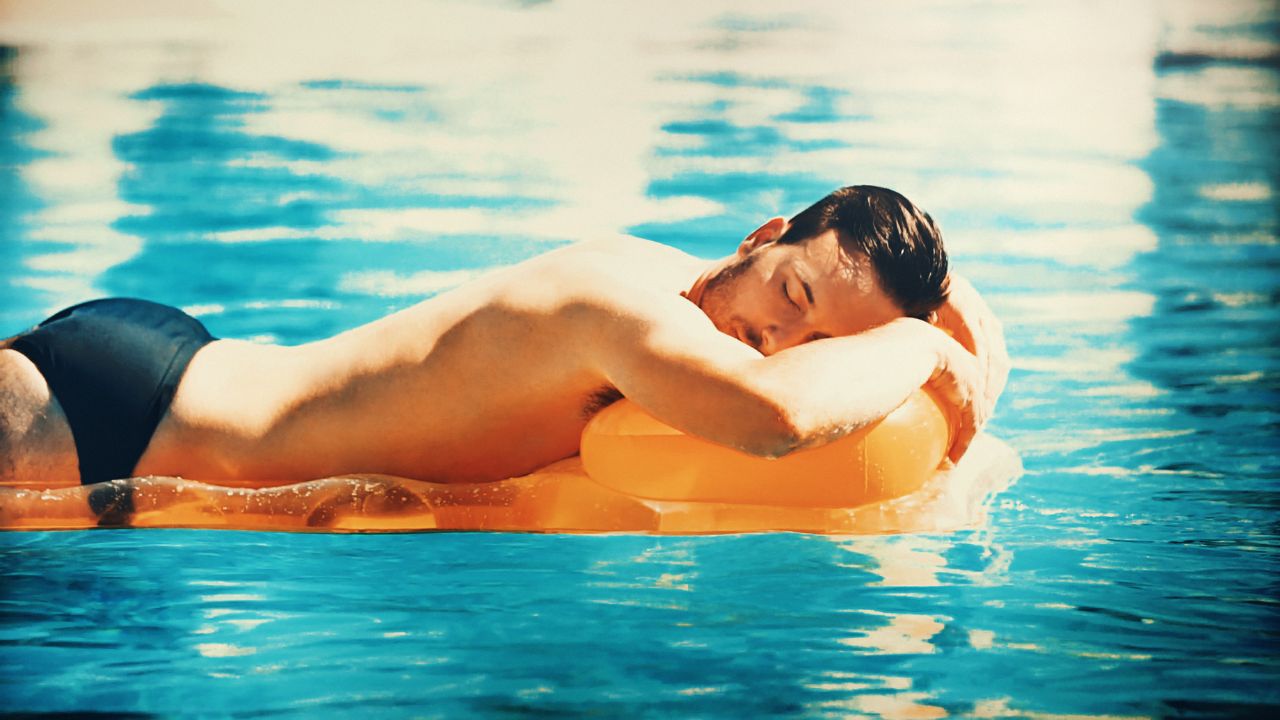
[0,391,950,534]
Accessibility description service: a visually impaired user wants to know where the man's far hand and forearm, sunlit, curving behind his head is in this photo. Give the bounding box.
[934,273,1009,460]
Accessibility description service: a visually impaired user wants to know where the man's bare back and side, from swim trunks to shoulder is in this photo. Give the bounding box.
[136,238,711,482]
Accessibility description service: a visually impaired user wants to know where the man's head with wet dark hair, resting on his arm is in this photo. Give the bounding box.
[687,186,947,355]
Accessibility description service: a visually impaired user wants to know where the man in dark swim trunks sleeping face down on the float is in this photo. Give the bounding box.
[0,186,1007,487]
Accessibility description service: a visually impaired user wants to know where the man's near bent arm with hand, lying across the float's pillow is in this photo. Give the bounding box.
[584,292,982,459]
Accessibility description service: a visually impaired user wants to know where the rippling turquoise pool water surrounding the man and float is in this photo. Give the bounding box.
[0,1,1280,717]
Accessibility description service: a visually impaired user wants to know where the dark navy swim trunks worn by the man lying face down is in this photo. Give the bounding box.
[12,299,215,484]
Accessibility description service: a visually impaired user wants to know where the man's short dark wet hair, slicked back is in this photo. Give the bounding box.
[778,184,947,320]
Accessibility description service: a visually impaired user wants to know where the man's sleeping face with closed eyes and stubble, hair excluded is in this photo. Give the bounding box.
[690,228,902,355]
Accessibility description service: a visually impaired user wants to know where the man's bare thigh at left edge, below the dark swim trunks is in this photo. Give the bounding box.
[0,341,79,488]
